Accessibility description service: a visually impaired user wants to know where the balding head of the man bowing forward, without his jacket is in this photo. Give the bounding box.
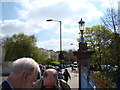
[43,69,57,88]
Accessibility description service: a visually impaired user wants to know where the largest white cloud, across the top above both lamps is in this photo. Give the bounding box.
[18,0,102,21]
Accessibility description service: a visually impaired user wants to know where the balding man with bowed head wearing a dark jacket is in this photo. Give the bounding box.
[34,69,71,90]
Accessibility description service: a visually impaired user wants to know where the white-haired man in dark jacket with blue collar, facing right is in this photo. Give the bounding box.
[1,58,40,90]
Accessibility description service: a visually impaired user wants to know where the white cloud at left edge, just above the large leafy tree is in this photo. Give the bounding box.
[1,19,50,35]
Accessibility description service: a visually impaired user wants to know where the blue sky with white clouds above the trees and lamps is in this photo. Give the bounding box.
[0,0,119,51]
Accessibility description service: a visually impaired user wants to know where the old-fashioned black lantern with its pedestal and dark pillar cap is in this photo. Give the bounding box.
[73,18,94,90]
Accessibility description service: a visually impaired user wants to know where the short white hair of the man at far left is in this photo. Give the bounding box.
[12,58,40,73]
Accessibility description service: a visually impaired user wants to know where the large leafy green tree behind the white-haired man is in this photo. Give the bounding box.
[4,33,47,62]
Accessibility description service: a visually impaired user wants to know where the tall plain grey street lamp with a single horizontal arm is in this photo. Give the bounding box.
[46,19,64,67]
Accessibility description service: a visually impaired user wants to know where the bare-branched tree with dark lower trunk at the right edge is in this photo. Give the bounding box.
[101,7,120,70]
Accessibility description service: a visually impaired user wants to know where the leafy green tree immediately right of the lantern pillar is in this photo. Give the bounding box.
[85,25,111,70]
